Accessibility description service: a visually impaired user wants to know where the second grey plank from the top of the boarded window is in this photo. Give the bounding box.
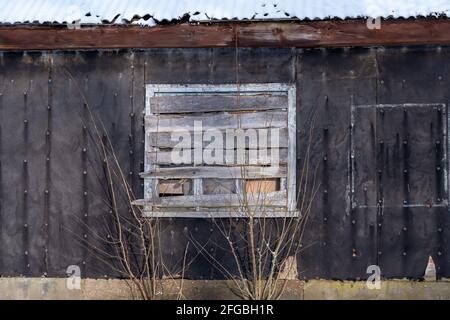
[145,111,287,132]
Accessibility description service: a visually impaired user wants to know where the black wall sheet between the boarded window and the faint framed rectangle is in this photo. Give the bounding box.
[297,49,376,279]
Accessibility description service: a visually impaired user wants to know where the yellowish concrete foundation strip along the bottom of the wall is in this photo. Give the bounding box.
[0,278,450,300]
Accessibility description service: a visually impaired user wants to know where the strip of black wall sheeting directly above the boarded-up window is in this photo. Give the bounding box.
[145,48,295,84]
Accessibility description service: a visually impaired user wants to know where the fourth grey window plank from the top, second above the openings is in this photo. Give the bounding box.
[147,148,288,166]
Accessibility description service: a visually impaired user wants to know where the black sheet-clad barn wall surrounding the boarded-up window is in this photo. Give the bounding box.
[0,47,450,279]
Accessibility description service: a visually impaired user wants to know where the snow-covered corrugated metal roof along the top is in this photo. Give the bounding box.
[0,0,450,25]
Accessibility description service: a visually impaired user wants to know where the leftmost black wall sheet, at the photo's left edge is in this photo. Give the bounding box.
[0,53,48,276]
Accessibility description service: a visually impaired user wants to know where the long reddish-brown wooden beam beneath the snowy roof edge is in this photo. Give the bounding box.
[0,18,450,50]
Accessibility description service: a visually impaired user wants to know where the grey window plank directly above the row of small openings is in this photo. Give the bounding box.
[141,166,287,179]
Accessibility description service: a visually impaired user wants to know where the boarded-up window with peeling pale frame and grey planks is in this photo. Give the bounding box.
[140,84,296,217]
